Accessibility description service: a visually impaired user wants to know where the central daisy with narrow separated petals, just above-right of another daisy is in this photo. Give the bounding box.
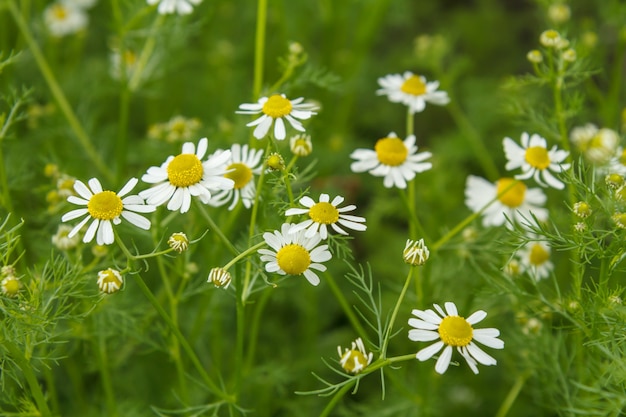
[285,194,367,239]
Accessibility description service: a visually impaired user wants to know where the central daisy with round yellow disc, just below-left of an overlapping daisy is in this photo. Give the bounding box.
[259,223,332,285]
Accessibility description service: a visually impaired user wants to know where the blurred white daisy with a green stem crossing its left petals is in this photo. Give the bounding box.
[465,175,548,228]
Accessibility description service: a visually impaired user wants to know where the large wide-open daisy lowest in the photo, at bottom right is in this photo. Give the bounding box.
[409,302,504,374]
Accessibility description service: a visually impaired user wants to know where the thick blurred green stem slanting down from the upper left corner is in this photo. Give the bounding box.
[7,0,112,181]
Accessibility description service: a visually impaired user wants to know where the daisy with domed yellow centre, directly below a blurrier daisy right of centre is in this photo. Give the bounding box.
[350,132,433,189]
